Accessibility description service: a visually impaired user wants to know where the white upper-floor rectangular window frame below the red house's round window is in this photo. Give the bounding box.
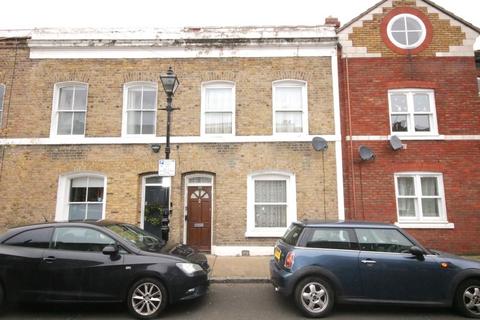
[388,88,439,136]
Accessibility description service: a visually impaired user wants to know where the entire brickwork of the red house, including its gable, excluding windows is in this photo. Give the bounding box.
[339,0,480,254]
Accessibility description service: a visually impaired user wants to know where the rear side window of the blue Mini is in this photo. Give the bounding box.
[306,228,357,250]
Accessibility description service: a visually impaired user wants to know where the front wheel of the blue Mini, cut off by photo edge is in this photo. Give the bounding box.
[455,280,480,319]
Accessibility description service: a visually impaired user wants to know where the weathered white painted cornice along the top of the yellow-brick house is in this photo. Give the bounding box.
[22,26,337,59]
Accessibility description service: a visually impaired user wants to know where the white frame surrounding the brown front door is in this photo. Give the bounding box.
[183,172,215,251]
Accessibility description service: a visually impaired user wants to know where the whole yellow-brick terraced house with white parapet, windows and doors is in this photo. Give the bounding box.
[0,25,343,255]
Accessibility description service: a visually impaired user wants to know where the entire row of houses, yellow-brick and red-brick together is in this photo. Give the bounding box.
[0,0,480,255]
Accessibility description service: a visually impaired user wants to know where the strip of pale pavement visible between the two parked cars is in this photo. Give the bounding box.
[207,255,273,283]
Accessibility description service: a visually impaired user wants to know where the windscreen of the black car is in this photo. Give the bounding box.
[107,224,165,252]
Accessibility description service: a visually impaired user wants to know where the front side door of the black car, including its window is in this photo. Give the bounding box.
[43,227,128,301]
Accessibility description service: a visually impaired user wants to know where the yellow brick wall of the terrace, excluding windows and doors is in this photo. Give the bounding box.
[0,38,343,251]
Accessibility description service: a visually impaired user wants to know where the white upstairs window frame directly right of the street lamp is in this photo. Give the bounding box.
[200,80,237,137]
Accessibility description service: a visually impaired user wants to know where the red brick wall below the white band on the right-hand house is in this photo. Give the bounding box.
[344,141,480,254]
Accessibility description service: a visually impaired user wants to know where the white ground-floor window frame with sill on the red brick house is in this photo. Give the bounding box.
[394,172,453,228]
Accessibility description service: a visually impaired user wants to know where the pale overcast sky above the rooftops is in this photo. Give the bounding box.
[0,0,480,49]
